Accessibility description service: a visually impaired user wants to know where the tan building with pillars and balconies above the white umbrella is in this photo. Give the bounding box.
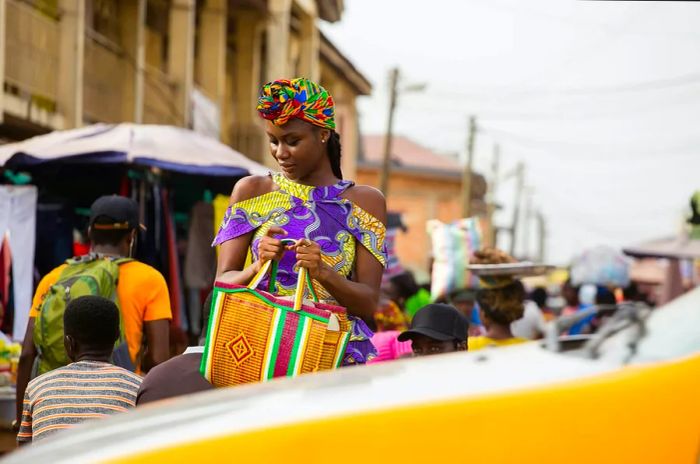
[0,0,371,177]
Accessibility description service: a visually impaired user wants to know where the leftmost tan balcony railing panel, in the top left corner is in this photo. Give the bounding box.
[5,0,60,103]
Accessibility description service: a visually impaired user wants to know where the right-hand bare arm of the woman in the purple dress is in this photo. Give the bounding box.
[296,186,386,320]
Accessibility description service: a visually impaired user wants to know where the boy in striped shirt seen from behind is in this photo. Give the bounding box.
[17,296,141,444]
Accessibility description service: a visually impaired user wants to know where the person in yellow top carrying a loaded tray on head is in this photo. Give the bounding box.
[468,248,527,351]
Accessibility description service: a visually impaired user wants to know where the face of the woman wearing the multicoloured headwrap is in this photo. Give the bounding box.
[265,119,330,181]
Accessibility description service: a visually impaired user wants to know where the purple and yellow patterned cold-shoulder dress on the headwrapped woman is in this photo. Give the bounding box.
[214,173,386,365]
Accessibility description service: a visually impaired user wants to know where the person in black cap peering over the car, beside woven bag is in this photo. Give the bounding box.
[398,303,469,356]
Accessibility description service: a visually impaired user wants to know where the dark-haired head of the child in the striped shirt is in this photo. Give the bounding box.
[63,296,119,361]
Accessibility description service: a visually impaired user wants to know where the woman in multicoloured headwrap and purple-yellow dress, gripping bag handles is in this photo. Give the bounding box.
[214,78,386,365]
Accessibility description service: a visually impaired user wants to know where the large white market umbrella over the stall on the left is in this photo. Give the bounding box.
[0,123,269,177]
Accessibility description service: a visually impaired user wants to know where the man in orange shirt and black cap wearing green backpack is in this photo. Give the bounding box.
[17,195,172,434]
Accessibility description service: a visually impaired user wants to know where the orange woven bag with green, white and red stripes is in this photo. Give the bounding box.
[201,261,350,387]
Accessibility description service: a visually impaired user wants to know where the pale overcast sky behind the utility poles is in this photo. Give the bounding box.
[323,0,700,263]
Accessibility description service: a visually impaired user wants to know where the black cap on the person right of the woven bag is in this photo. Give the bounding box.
[399,303,469,342]
